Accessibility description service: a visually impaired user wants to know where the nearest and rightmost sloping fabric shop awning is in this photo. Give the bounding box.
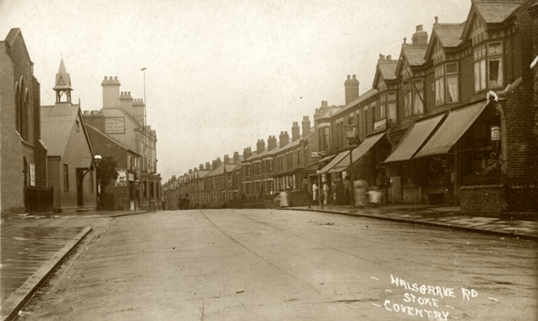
[414,102,487,158]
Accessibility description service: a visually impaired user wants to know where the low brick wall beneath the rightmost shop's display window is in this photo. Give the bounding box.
[460,184,506,217]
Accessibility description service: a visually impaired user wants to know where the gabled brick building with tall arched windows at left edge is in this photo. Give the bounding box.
[0,28,49,213]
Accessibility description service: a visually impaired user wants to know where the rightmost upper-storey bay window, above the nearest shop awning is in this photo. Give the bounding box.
[474,42,503,92]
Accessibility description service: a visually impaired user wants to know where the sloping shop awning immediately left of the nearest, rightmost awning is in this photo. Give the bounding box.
[384,114,445,163]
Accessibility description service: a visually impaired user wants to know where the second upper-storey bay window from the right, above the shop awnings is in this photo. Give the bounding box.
[435,62,459,106]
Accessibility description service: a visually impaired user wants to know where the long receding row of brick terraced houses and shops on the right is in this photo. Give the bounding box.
[163,0,538,215]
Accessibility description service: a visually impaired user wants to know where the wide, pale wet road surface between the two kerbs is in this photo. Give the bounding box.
[12,210,538,320]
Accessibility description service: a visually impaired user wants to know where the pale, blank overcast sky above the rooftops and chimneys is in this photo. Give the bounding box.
[0,0,471,182]
